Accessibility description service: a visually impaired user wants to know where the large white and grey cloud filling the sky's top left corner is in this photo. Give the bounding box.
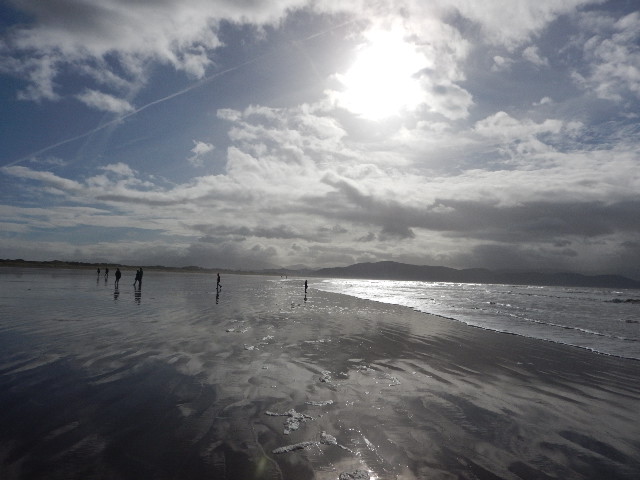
[0,0,316,101]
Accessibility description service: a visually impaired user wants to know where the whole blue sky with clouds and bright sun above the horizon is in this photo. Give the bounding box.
[0,0,640,279]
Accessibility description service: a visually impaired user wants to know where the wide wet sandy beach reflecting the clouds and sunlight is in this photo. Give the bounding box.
[0,269,640,480]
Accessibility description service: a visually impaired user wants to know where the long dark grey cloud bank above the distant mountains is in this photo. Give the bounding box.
[308,174,640,249]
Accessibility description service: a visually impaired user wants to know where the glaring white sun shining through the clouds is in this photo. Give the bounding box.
[336,30,426,120]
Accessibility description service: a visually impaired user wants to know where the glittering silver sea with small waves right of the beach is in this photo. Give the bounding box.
[313,279,640,360]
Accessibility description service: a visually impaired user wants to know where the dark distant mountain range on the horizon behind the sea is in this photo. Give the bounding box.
[310,261,640,288]
